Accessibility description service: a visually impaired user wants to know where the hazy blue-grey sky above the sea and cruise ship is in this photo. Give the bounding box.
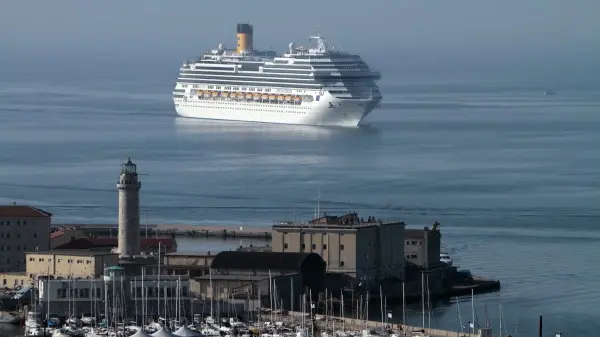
[0,0,600,79]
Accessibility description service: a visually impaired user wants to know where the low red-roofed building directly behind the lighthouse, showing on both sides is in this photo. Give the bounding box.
[55,237,177,254]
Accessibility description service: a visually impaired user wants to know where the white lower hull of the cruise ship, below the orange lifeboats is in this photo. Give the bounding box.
[174,94,379,127]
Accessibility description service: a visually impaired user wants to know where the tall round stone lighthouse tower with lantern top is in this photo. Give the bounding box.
[117,158,142,258]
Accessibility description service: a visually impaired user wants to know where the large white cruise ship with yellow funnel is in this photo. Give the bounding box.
[173,23,381,127]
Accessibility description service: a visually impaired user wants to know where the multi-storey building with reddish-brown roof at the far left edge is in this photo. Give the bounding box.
[0,205,52,273]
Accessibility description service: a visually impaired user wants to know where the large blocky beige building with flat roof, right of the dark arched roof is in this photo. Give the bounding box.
[272,213,405,279]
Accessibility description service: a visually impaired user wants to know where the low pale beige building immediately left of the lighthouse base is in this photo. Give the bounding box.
[26,250,119,278]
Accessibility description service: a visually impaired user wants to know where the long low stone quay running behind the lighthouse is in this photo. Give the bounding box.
[54,224,271,239]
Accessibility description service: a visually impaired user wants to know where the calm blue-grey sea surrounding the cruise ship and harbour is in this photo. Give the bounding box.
[0,67,600,336]
